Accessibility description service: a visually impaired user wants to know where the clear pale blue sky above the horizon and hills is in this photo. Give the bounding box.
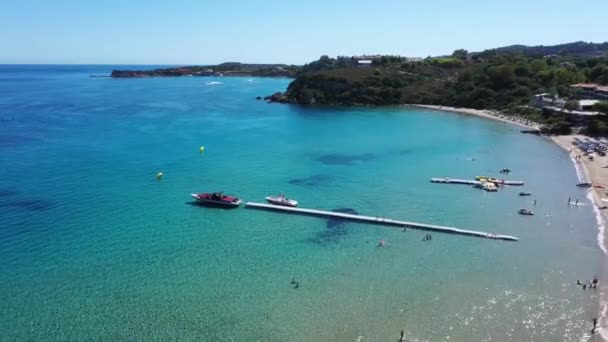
[0,0,608,65]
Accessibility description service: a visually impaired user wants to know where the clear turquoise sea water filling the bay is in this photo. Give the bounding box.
[0,66,603,341]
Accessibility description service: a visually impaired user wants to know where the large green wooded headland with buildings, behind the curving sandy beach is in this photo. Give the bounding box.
[268,42,608,135]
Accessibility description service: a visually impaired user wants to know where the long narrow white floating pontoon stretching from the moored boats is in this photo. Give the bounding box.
[245,202,519,241]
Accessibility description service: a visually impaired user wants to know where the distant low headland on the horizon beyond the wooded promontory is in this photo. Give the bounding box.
[110,62,300,78]
